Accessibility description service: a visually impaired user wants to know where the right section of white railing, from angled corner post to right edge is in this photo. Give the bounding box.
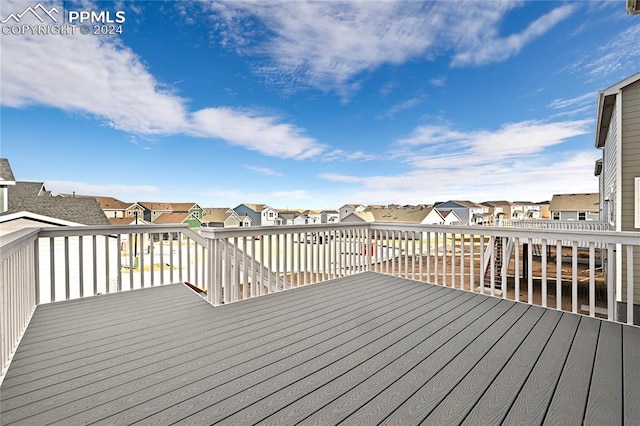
[202,223,640,323]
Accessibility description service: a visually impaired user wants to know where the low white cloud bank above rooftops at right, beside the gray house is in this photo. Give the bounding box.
[318,120,600,204]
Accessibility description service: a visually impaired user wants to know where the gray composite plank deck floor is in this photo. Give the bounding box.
[0,272,640,425]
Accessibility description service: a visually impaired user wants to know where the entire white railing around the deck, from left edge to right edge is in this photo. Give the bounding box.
[0,223,640,382]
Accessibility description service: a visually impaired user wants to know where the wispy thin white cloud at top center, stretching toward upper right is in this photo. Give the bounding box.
[203,1,574,96]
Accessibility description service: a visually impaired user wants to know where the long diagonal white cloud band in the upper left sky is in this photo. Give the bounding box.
[0,2,325,158]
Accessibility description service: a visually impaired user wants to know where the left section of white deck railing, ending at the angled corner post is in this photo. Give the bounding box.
[0,225,209,377]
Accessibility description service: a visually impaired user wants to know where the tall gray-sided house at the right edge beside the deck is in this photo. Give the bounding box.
[595,73,640,323]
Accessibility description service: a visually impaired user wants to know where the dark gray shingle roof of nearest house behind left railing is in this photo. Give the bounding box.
[3,182,110,225]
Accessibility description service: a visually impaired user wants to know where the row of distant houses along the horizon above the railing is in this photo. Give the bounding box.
[0,159,601,233]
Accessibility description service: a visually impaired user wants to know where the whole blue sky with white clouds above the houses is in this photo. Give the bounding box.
[0,0,640,208]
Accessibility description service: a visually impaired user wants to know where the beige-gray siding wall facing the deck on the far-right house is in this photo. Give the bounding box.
[621,81,640,304]
